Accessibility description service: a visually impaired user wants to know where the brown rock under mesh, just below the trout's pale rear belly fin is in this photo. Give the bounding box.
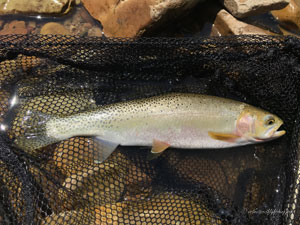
[59,159,126,209]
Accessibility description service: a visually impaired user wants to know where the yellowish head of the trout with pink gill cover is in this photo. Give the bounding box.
[236,106,286,142]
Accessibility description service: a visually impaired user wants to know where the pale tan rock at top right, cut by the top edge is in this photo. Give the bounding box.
[220,0,290,18]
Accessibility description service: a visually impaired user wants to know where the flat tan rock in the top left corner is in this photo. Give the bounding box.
[0,0,74,14]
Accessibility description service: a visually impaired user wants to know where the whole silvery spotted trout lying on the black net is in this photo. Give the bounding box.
[15,93,285,161]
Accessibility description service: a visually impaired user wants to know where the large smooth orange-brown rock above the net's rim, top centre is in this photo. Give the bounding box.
[82,0,203,37]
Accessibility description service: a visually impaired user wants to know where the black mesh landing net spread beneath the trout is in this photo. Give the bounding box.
[0,35,300,225]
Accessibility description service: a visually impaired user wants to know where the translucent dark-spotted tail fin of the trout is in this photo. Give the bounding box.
[14,110,60,151]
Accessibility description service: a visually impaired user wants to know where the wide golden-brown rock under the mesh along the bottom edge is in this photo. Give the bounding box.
[41,193,222,225]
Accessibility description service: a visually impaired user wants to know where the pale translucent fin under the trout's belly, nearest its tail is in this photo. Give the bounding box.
[94,137,119,163]
